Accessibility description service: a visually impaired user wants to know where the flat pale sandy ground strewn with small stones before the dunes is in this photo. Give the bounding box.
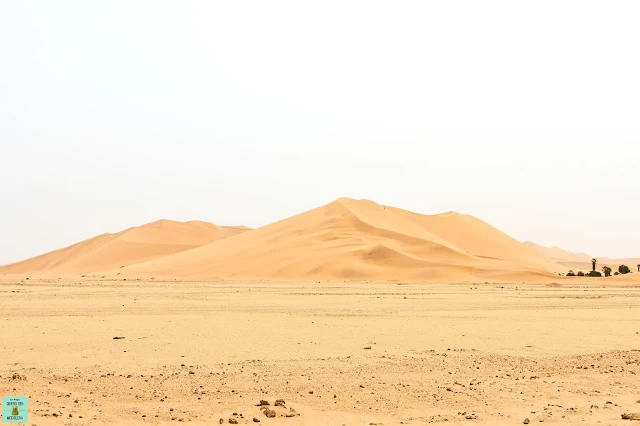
[0,278,640,425]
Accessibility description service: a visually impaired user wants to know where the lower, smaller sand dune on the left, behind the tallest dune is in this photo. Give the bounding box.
[0,220,249,274]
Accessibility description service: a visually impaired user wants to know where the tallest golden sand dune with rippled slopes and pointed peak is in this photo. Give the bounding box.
[122,198,558,281]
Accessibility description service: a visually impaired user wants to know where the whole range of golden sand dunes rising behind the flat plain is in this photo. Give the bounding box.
[6,198,640,282]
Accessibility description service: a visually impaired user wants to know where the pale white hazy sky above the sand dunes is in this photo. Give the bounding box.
[0,0,640,264]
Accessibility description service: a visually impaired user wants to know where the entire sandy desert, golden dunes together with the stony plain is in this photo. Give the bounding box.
[0,199,640,425]
